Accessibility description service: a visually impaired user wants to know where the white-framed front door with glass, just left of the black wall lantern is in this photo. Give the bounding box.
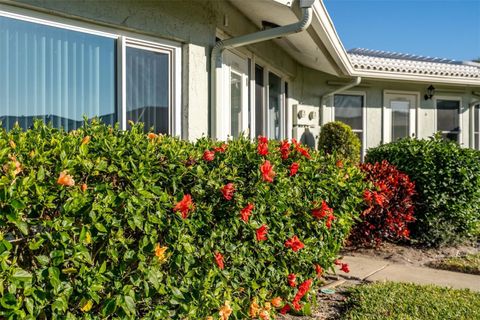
[383,92,418,143]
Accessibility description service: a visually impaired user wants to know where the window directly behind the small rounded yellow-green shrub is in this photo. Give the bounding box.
[334,94,363,142]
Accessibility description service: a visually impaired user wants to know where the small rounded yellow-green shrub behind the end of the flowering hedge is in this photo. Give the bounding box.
[318,121,361,162]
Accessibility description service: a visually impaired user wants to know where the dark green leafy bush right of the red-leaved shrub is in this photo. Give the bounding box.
[366,137,480,246]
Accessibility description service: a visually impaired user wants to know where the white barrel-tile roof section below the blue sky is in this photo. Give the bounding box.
[348,49,480,79]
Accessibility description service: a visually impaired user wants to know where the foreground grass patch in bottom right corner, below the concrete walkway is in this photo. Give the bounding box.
[342,282,480,320]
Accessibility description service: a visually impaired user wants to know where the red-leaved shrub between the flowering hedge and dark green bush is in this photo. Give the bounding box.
[350,160,415,247]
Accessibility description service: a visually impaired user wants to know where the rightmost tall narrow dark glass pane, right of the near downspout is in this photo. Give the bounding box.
[268,72,282,140]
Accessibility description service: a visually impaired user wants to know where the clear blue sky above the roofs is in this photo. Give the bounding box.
[323,0,480,61]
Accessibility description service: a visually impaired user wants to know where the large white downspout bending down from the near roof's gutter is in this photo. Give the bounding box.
[210,0,316,140]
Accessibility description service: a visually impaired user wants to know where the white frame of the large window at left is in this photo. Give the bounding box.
[0,4,182,136]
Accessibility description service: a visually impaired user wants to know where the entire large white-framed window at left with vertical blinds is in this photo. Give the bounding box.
[0,11,180,134]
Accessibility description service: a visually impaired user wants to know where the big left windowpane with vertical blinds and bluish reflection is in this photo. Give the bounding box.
[0,17,116,130]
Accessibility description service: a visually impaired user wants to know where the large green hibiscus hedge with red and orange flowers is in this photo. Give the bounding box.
[0,121,364,319]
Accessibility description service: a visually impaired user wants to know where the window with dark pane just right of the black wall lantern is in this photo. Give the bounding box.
[437,99,460,142]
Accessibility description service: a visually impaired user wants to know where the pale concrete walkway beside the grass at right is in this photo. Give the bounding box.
[337,255,480,291]
